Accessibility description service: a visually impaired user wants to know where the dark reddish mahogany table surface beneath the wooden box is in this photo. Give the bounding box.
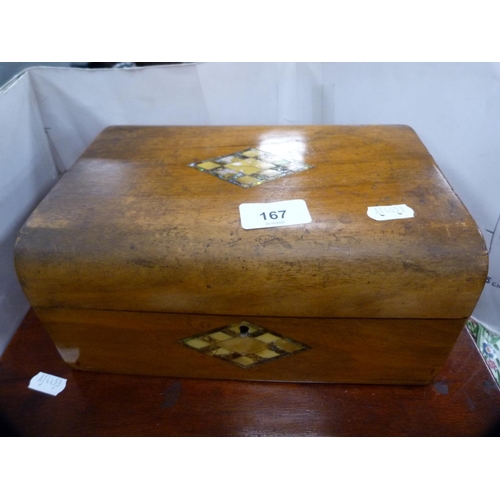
[0,311,500,436]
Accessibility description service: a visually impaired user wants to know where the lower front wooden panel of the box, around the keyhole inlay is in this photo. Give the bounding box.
[36,308,463,384]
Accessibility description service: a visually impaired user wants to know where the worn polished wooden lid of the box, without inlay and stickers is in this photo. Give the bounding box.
[16,126,487,319]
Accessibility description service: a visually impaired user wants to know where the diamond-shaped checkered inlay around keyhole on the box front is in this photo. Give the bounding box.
[179,321,310,368]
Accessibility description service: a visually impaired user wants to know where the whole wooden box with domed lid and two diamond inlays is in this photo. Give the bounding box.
[15,126,487,384]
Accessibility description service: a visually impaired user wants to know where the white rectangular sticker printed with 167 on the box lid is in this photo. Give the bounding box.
[240,200,312,229]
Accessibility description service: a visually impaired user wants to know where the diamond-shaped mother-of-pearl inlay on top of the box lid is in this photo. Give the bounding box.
[189,148,312,187]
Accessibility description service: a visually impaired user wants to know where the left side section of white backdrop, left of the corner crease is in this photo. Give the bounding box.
[0,78,57,353]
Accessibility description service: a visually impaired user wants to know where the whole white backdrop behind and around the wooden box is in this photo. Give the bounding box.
[0,63,500,353]
